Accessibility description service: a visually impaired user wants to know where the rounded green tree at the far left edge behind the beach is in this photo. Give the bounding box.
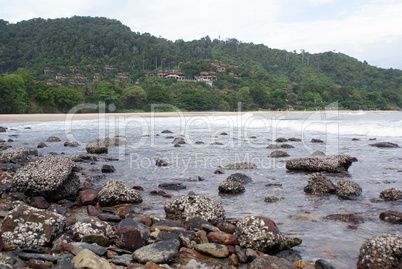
[0,74,29,114]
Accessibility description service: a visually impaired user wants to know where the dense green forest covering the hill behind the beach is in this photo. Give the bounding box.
[0,17,402,113]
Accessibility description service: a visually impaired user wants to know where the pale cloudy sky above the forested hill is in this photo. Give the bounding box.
[0,0,402,69]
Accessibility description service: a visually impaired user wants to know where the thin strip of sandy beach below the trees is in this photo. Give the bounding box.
[0,110,401,124]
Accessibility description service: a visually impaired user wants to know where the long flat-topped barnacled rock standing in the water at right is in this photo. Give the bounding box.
[286,155,355,173]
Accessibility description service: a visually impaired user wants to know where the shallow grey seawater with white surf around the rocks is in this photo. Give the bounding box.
[0,112,402,268]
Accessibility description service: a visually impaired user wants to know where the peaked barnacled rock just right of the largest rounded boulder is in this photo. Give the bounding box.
[98,179,142,206]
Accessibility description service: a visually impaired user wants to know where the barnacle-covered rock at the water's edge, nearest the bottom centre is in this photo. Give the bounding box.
[164,194,225,223]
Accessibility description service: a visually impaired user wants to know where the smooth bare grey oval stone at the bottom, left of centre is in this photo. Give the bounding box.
[133,241,179,264]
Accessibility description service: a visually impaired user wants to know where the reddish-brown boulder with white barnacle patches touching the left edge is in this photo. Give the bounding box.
[1,205,66,248]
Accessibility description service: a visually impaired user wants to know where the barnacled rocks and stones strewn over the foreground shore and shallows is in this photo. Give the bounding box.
[0,129,402,269]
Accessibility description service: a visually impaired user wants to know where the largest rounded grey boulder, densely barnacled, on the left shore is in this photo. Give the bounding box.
[12,156,80,201]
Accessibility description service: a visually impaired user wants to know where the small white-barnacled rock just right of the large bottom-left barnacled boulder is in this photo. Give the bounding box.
[69,217,113,239]
